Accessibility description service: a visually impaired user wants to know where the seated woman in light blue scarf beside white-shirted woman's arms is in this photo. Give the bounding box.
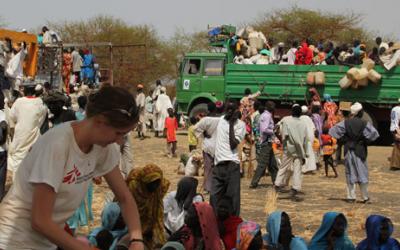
[88,202,128,250]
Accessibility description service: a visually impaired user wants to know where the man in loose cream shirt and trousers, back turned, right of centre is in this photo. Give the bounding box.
[275,104,310,201]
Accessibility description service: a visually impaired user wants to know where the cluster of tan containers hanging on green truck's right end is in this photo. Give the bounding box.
[339,58,382,89]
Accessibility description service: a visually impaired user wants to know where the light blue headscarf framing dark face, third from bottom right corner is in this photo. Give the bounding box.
[263,210,308,250]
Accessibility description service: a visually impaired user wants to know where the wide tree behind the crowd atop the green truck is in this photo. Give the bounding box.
[251,6,372,43]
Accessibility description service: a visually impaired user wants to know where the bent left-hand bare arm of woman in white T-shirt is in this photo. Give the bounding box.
[31,183,92,250]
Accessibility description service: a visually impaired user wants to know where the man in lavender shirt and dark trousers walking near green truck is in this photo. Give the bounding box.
[250,101,278,188]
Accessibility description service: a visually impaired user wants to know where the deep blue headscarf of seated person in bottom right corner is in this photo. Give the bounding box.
[357,215,400,250]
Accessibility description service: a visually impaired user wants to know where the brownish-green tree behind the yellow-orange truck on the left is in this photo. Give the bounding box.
[48,15,169,91]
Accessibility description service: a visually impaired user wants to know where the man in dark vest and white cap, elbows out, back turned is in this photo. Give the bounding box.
[329,102,379,203]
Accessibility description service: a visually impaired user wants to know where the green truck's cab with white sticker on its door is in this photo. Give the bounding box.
[176,53,227,116]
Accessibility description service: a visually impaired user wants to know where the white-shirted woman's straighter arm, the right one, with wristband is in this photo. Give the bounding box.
[104,166,144,249]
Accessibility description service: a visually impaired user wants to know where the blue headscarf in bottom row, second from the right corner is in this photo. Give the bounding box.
[308,212,355,250]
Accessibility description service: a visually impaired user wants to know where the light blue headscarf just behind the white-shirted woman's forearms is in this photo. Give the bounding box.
[88,202,128,250]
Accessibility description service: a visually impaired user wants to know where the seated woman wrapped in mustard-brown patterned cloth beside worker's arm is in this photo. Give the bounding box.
[126,164,169,249]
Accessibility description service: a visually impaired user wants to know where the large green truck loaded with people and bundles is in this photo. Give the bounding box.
[176,36,400,144]
